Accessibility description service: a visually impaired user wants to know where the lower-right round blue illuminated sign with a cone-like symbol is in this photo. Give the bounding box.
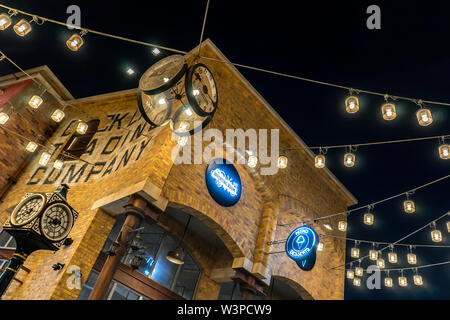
[286,226,319,271]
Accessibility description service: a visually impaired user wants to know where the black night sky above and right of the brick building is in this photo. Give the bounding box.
[0,0,450,299]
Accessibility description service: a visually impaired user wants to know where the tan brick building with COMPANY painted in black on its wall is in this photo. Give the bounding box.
[0,40,356,299]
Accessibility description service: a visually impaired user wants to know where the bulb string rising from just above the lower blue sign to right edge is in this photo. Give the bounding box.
[278,174,450,230]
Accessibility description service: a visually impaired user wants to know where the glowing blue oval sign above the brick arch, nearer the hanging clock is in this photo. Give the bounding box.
[205,158,242,207]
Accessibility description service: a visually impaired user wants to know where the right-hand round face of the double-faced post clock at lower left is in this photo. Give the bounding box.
[41,203,73,242]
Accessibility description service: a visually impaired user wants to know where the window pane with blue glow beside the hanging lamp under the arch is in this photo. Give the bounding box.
[150,236,178,289]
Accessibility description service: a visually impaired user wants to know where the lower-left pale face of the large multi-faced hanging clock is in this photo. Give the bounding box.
[138,89,172,126]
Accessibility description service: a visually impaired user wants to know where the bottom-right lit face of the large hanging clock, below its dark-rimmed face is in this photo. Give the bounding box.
[170,104,211,136]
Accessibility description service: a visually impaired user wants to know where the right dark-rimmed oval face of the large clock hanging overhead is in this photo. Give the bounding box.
[186,64,218,116]
